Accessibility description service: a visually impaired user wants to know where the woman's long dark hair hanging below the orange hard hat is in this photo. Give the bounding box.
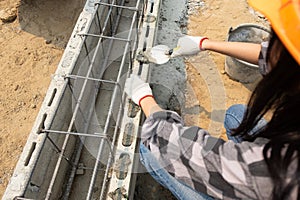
[233,32,300,199]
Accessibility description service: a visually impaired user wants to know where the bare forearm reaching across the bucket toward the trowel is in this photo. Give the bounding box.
[202,40,261,64]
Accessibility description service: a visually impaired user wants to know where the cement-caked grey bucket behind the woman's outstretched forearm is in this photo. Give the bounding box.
[225,24,270,83]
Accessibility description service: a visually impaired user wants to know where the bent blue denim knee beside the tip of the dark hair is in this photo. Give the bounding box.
[224,104,246,130]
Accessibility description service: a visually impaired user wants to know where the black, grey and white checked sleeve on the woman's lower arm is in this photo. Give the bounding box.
[141,111,271,199]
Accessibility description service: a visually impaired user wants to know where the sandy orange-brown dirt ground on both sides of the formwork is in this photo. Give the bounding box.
[0,0,262,196]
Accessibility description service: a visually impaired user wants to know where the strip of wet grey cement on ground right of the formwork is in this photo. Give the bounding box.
[150,0,187,113]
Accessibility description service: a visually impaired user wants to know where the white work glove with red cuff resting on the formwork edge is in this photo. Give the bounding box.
[124,74,153,106]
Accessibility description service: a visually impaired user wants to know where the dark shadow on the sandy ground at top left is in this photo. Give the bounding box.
[18,0,85,48]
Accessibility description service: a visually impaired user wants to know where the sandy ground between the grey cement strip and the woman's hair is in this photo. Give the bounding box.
[186,0,268,139]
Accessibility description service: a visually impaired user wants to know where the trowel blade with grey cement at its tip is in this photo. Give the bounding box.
[137,45,173,65]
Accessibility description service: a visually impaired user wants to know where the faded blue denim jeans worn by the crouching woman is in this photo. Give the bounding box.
[140,104,266,200]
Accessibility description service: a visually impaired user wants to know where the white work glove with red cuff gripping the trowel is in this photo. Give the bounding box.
[171,35,208,57]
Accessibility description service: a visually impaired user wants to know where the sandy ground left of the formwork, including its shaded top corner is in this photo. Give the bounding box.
[0,0,85,196]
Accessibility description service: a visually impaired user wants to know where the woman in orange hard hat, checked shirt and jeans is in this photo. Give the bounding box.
[125,0,300,199]
